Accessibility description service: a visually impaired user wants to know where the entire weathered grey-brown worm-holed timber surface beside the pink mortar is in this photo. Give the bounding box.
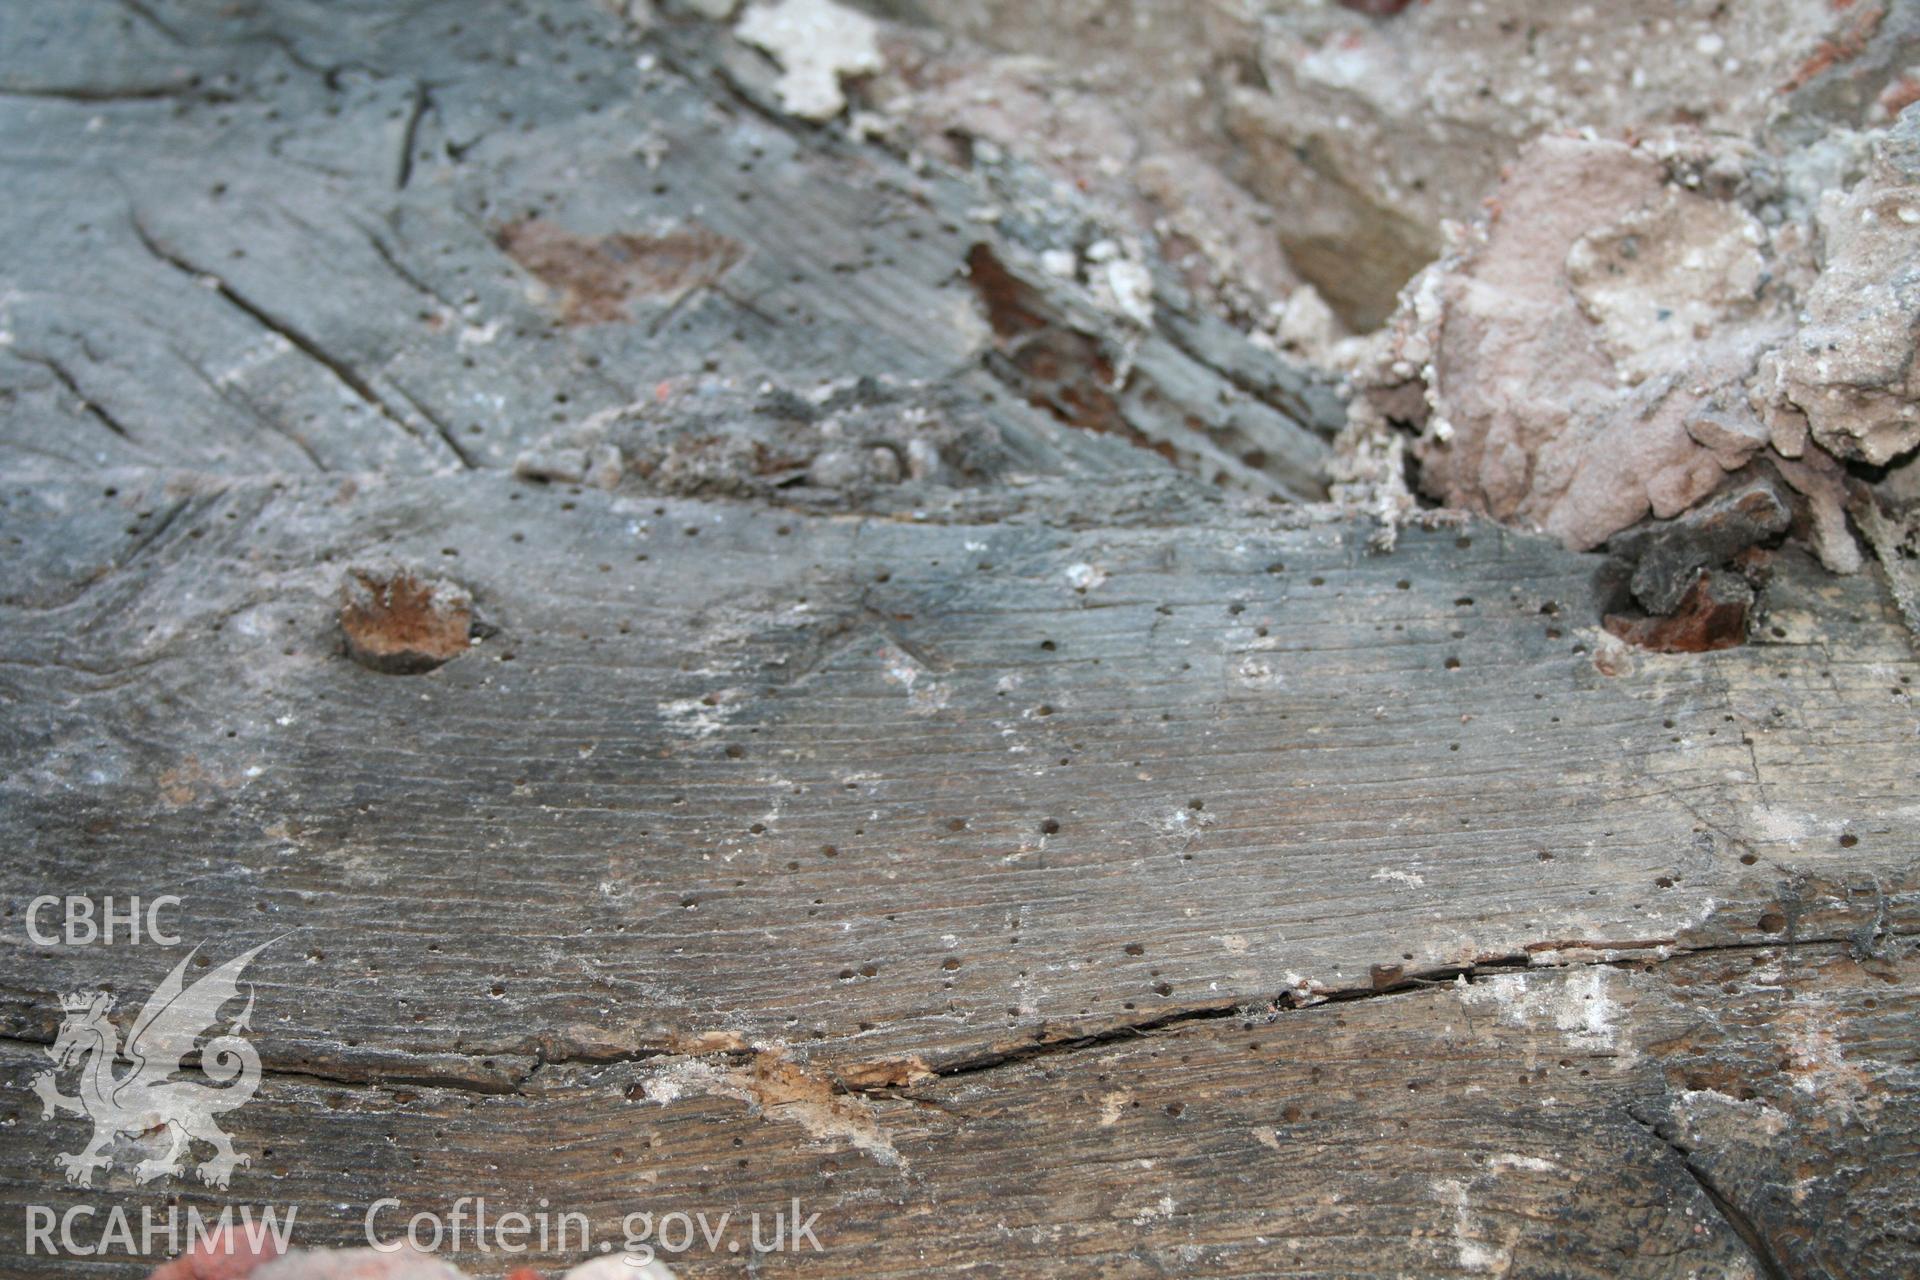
[0,2,1920,1276]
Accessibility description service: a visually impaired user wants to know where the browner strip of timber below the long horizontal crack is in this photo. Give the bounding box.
[4,942,1920,1276]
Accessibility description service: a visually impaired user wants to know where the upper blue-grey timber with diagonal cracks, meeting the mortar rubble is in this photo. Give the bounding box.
[0,0,1336,493]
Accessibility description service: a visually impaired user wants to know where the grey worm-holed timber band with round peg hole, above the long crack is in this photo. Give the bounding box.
[6,476,1912,1069]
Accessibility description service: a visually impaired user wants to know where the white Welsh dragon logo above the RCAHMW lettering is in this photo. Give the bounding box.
[33,942,271,1188]
